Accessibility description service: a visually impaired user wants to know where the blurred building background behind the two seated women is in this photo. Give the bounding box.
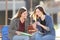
[0,0,60,40]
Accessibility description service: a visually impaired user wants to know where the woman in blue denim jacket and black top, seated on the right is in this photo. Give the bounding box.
[32,6,55,40]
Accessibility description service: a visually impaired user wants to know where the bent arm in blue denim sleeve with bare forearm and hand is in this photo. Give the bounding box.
[36,16,54,31]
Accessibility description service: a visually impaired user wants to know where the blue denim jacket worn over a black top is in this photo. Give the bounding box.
[37,15,55,36]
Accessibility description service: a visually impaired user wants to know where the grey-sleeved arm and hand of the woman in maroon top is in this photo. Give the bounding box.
[9,20,21,35]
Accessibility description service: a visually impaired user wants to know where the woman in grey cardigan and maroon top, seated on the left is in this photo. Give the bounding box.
[9,7,29,40]
